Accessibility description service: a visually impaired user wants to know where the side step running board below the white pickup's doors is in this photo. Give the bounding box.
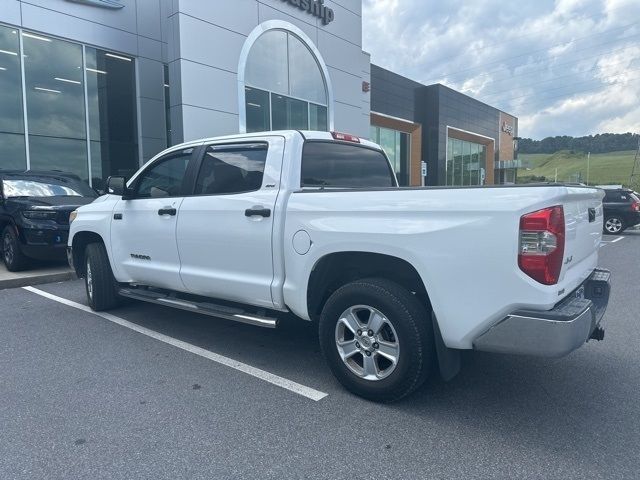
[118,287,278,328]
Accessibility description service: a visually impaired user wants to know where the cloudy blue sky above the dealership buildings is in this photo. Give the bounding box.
[363,0,640,139]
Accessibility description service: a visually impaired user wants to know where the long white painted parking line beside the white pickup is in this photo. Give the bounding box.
[23,287,328,402]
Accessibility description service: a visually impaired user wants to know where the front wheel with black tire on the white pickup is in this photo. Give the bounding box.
[84,243,120,312]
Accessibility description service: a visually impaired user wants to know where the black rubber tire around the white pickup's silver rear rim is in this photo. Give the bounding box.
[319,278,435,402]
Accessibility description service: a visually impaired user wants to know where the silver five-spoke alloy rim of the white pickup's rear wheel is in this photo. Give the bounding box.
[335,305,400,381]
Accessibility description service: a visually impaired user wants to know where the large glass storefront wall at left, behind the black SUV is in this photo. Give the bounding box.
[0,26,138,188]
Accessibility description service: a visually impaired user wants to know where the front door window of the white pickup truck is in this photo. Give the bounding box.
[136,148,193,198]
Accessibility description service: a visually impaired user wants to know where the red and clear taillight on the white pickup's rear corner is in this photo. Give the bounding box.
[518,205,565,285]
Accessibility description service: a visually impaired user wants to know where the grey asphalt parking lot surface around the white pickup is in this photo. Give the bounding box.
[0,231,640,479]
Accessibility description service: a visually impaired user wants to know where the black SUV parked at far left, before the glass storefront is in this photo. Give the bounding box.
[0,171,98,272]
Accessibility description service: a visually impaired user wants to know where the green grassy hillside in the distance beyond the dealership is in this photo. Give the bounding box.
[518,150,636,186]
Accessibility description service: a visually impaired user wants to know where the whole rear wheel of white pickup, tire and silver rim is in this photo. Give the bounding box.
[320,278,435,402]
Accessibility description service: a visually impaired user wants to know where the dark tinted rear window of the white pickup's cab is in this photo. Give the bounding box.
[302,141,396,188]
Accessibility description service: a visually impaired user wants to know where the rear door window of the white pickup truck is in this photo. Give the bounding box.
[195,144,268,195]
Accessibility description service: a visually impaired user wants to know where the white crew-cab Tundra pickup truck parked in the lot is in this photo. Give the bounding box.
[68,131,609,401]
